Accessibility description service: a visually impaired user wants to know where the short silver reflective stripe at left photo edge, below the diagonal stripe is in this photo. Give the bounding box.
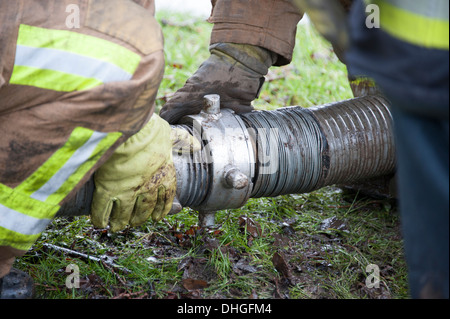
[0,204,52,235]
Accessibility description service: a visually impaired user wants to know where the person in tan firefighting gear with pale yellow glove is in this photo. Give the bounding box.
[0,0,199,298]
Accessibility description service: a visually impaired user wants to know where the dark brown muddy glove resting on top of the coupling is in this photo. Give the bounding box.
[160,43,277,124]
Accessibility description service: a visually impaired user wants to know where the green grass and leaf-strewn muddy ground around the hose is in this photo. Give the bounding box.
[15,13,408,299]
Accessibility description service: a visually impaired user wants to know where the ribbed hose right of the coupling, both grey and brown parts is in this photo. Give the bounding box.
[241,96,395,197]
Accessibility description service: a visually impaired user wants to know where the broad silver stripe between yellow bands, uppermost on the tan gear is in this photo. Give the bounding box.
[14,45,133,83]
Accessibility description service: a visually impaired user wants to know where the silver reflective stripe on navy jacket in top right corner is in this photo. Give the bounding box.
[387,0,449,21]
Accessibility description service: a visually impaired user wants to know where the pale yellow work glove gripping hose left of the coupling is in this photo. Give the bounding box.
[91,114,200,232]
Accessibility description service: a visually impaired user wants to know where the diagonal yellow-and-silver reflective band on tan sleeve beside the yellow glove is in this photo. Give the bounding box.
[16,127,122,204]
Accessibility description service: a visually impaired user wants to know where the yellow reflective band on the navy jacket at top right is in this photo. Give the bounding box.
[372,0,449,50]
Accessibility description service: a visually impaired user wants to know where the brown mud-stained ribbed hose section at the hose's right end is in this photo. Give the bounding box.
[311,96,396,186]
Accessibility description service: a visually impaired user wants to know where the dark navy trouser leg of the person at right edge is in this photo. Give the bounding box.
[393,102,449,298]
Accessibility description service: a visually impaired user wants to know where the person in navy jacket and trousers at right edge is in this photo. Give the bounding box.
[345,0,449,299]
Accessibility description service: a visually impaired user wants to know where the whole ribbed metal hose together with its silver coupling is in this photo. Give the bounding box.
[55,95,396,226]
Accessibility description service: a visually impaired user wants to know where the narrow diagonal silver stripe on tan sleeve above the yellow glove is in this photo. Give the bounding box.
[30,132,108,202]
